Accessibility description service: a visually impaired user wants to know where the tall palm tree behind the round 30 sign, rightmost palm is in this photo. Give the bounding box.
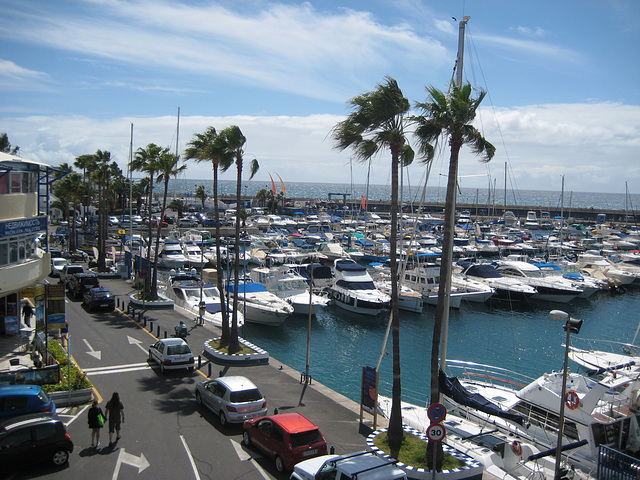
[413,83,496,469]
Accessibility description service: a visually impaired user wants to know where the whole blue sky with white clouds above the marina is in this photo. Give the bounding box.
[0,0,640,194]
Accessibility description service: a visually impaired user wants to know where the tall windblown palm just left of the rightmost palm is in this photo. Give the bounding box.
[333,77,414,458]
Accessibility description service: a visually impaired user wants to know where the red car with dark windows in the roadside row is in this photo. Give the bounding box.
[242,413,327,472]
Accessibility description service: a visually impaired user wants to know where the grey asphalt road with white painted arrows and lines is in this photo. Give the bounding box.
[8,280,288,480]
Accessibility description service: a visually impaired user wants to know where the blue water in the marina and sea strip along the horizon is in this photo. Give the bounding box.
[170,179,640,404]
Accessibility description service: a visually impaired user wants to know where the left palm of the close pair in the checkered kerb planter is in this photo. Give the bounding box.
[184,127,233,346]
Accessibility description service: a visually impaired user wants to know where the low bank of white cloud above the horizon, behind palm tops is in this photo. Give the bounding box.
[1,103,640,193]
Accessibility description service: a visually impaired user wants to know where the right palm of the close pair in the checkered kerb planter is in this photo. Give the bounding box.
[219,125,260,354]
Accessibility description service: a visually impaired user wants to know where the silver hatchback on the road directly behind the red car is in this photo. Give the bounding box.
[196,376,267,426]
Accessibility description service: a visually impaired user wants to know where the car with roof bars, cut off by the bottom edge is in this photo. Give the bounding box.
[290,451,407,480]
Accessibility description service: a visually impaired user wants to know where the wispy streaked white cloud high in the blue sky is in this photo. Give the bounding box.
[0,0,451,101]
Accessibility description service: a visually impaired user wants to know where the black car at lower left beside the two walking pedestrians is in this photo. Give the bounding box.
[0,413,73,471]
